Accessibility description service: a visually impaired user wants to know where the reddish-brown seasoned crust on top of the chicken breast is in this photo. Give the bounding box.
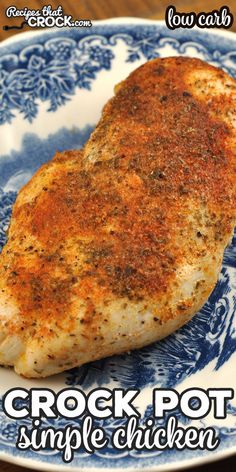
[1,58,235,336]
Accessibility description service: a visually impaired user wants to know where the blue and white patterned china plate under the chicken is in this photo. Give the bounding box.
[0,18,236,472]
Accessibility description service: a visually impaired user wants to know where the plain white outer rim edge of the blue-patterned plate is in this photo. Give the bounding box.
[0,16,236,472]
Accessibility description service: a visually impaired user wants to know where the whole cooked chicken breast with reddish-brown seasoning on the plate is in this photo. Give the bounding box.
[0,57,236,377]
